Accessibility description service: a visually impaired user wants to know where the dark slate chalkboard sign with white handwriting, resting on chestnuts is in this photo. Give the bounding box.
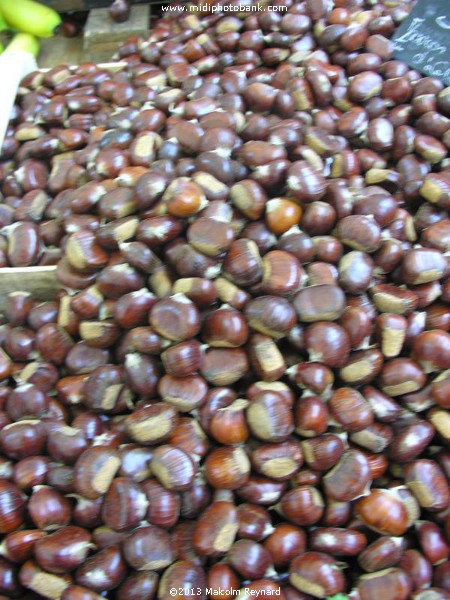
[392,0,450,85]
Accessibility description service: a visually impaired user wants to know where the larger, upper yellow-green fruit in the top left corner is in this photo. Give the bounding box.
[0,0,61,37]
